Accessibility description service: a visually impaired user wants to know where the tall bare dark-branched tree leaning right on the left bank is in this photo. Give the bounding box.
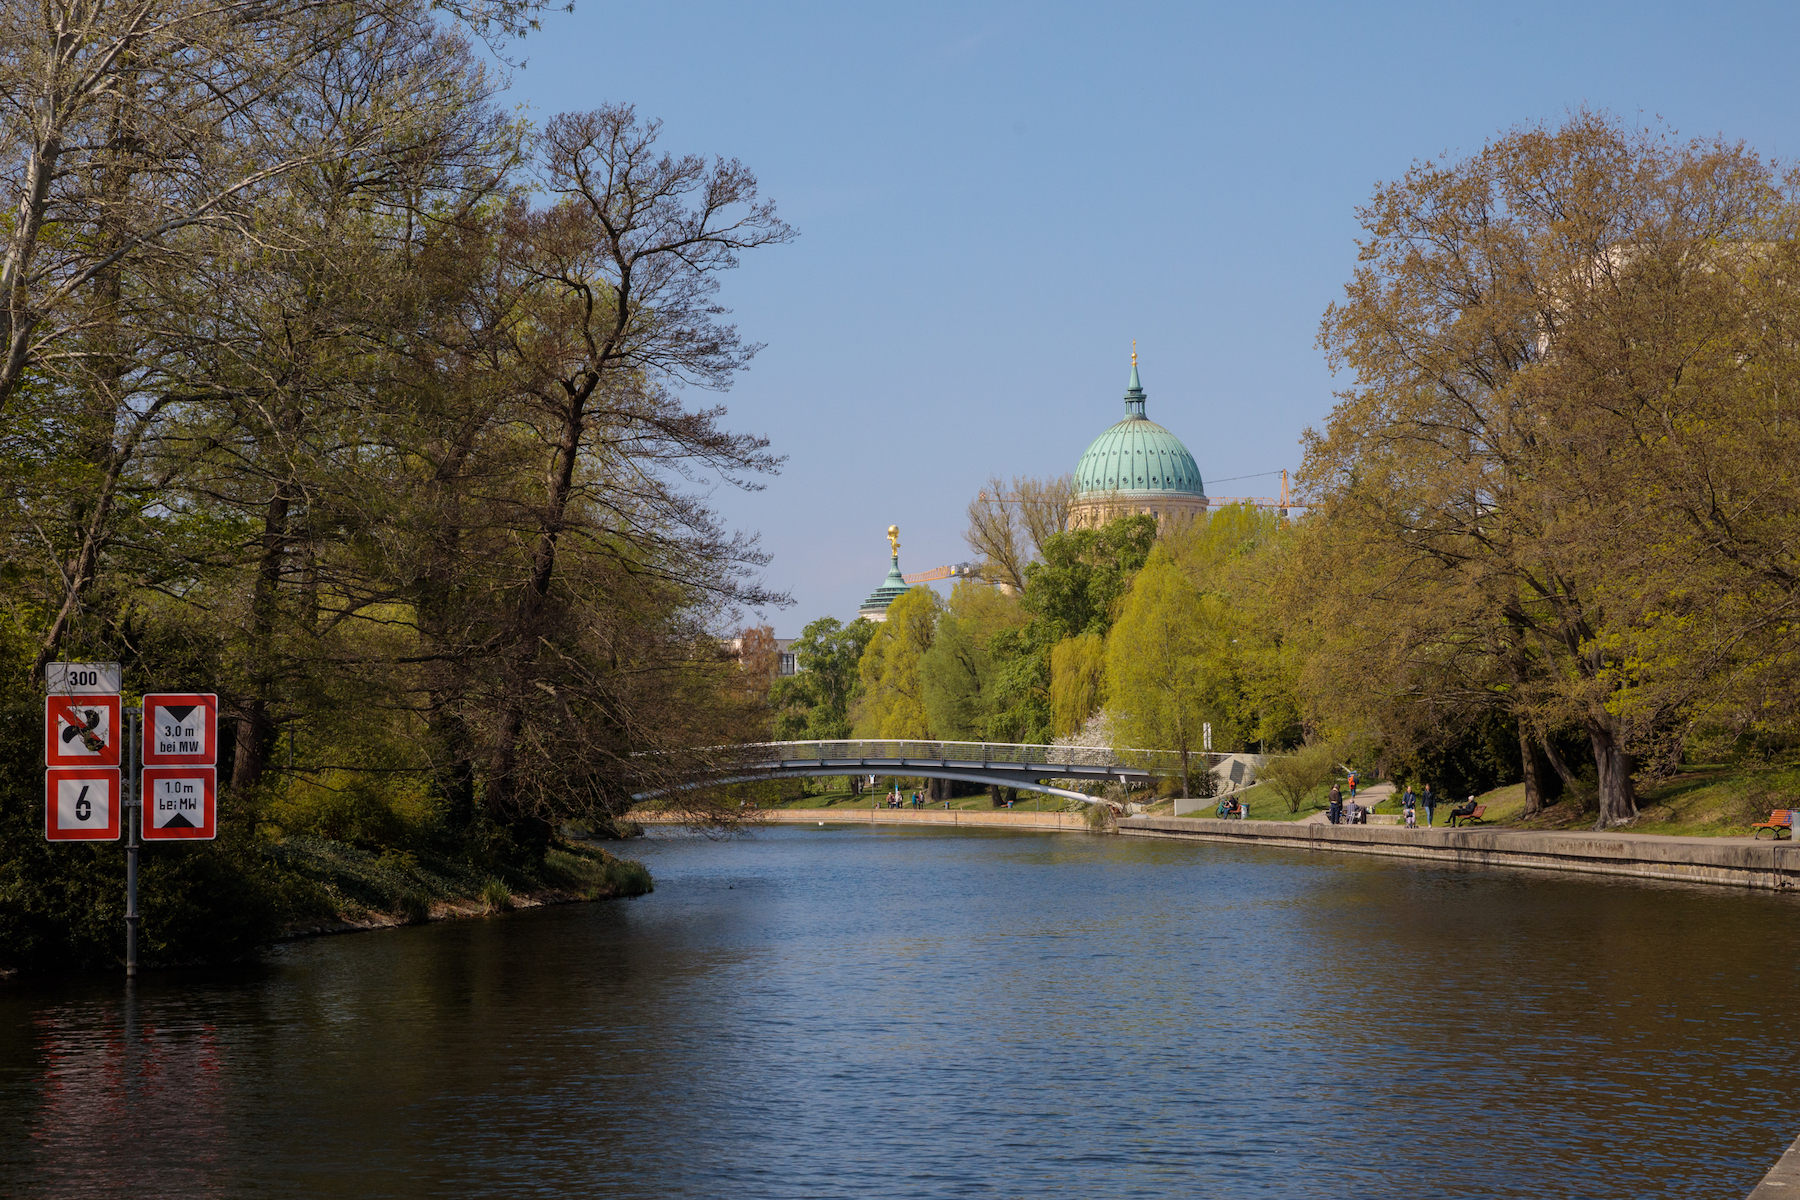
[486,104,794,824]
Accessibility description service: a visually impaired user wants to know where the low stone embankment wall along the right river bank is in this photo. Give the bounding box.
[1118,817,1800,891]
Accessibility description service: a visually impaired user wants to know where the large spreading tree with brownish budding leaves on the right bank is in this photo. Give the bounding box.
[1303,112,1795,828]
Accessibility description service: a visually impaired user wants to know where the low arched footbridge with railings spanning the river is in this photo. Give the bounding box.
[632,739,1255,802]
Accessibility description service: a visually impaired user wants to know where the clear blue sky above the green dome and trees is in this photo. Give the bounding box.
[493,0,1800,637]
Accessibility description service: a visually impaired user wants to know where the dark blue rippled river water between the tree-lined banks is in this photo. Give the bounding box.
[0,828,1800,1200]
